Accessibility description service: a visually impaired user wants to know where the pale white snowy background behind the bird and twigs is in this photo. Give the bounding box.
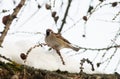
[0,0,120,73]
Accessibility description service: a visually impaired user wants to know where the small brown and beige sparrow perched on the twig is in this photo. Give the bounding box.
[45,29,80,51]
